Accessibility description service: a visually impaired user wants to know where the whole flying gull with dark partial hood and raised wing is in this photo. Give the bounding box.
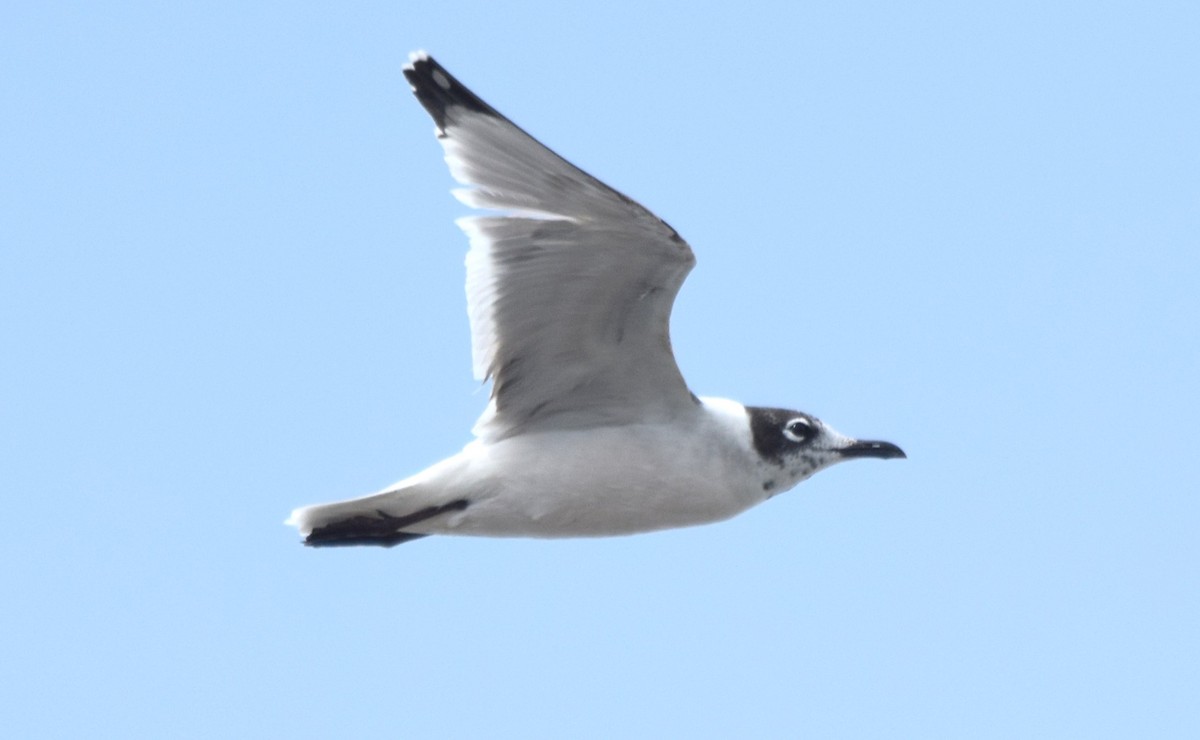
[288,53,904,546]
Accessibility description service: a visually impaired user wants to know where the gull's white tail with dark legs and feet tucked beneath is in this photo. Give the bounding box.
[284,489,468,547]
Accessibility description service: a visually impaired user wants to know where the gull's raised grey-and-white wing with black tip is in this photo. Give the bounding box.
[404,53,696,440]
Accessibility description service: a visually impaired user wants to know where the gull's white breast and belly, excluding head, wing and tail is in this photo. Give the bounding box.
[427,399,767,537]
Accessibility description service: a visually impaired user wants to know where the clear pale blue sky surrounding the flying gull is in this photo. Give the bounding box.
[0,1,1200,738]
